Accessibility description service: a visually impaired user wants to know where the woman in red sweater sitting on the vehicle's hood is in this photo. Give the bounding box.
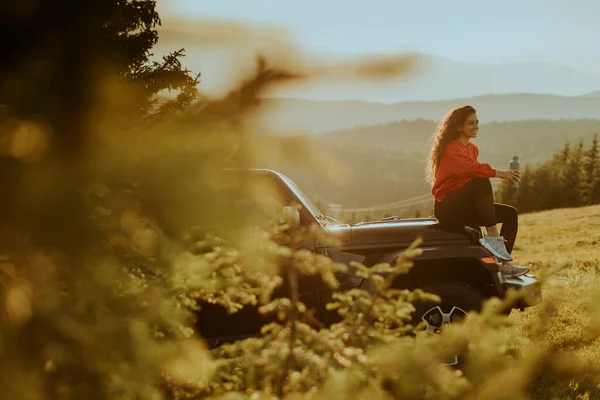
[427,105,529,278]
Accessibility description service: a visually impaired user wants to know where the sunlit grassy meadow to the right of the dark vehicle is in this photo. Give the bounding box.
[511,206,600,399]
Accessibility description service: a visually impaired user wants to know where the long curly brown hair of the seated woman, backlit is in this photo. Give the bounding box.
[425,105,476,185]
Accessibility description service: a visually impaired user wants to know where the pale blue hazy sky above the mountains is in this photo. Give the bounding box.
[158,0,600,101]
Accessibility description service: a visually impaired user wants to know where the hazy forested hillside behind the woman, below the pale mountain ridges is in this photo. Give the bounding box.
[265,120,600,212]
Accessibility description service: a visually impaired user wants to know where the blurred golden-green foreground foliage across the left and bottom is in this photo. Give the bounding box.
[0,0,599,400]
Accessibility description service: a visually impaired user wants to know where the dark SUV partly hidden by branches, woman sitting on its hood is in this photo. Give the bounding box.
[198,169,541,344]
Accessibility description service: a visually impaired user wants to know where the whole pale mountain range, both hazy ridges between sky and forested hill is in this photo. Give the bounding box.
[247,54,600,134]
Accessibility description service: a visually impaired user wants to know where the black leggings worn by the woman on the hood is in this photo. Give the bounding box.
[433,178,519,253]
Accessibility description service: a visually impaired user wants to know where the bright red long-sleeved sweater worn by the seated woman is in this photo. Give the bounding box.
[431,139,496,200]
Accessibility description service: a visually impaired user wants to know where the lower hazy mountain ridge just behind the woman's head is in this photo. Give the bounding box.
[257,91,600,134]
